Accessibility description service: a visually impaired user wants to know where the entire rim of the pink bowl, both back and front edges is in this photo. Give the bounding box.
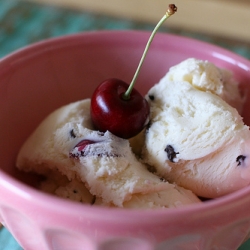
[0,30,250,220]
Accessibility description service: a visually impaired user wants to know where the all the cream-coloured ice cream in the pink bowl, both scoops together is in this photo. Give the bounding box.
[17,58,250,205]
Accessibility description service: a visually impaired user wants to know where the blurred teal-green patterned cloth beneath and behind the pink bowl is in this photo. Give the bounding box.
[0,0,250,250]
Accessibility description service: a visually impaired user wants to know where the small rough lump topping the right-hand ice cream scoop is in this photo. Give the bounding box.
[166,58,244,113]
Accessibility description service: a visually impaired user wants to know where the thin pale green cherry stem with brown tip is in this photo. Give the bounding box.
[123,4,177,100]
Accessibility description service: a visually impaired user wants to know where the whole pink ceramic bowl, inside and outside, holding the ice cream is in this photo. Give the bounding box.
[0,31,250,250]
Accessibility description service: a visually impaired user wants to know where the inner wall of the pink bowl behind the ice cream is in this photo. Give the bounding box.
[0,31,250,189]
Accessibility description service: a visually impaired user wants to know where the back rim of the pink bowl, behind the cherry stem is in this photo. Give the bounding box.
[0,30,250,71]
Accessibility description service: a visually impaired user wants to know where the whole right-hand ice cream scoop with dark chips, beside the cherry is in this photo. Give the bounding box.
[143,58,250,198]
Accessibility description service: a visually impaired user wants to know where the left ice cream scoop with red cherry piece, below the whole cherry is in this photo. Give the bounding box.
[17,99,200,208]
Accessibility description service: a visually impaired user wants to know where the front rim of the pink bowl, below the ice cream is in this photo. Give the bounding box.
[0,165,250,220]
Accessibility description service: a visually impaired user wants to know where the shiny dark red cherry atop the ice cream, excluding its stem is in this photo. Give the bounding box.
[91,78,149,139]
